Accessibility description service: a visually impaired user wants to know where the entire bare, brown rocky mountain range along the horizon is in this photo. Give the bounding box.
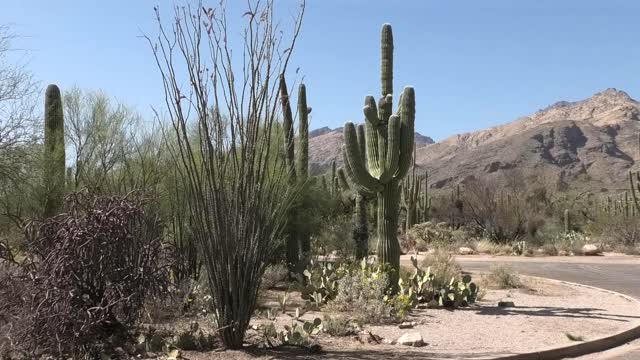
[310,89,640,191]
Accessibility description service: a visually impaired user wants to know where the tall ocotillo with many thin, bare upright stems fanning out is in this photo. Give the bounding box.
[147,0,304,348]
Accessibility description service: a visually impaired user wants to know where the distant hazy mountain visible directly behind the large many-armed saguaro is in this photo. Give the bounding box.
[309,126,435,175]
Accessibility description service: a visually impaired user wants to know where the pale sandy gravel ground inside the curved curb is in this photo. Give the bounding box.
[169,278,640,360]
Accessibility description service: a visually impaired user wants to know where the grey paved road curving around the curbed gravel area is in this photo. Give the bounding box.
[457,257,640,360]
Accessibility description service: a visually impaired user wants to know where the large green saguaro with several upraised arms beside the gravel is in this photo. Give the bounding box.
[343,24,415,291]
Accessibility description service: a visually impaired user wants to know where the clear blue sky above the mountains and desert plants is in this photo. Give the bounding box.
[0,0,640,139]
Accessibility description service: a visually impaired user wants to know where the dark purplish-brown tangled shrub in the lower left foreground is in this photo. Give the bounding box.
[0,192,167,357]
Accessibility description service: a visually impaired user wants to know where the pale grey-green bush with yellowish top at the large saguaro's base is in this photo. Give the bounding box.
[330,266,393,324]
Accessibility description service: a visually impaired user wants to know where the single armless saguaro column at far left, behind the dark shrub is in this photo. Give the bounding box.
[44,85,66,217]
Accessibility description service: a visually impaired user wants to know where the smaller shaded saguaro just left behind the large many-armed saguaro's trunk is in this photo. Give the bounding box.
[338,168,373,260]
